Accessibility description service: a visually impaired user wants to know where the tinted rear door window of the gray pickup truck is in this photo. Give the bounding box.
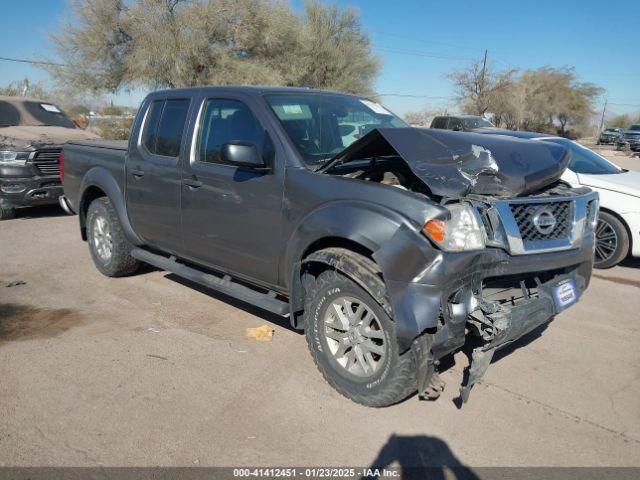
[142,98,189,157]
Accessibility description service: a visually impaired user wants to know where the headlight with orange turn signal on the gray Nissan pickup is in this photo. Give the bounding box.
[424,205,486,252]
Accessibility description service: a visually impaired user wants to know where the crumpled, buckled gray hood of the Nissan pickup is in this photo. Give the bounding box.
[330,128,570,198]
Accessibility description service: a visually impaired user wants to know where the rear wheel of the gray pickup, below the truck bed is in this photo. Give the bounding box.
[87,197,140,277]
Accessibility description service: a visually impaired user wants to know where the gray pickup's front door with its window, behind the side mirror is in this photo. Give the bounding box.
[182,97,283,285]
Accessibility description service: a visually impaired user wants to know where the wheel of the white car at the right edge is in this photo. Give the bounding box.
[593,212,629,269]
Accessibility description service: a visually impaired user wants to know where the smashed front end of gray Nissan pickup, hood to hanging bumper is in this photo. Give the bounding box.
[327,129,598,401]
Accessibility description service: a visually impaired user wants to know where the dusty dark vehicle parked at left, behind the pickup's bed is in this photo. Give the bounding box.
[0,96,98,220]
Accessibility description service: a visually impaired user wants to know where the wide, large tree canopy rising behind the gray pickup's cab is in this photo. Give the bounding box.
[47,0,379,93]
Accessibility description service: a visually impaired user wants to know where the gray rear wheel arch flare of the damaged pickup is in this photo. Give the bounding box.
[78,166,143,245]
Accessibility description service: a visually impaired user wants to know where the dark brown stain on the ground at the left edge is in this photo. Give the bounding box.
[0,303,84,346]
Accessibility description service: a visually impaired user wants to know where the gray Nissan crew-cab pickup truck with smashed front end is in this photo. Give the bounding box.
[63,87,598,407]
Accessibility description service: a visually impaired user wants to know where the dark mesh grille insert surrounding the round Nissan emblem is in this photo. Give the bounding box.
[510,201,572,242]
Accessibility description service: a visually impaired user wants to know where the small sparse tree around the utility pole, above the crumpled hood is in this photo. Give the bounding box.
[447,60,517,115]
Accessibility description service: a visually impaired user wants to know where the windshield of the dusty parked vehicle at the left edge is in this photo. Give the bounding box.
[0,98,75,128]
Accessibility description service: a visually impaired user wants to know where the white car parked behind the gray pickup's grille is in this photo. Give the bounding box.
[472,130,640,268]
